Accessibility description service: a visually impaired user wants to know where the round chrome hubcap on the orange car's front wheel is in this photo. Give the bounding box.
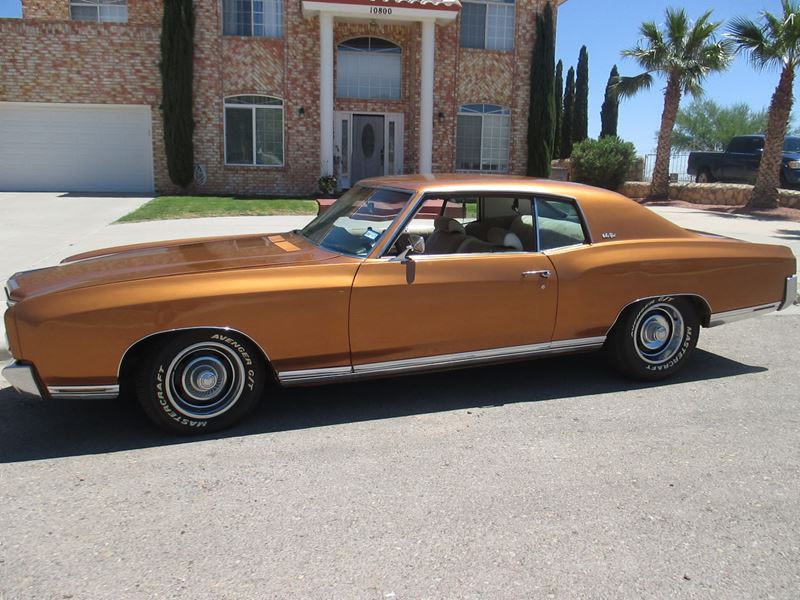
[165,342,245,419]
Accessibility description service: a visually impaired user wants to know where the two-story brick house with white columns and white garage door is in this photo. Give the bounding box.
[0,0,564,194]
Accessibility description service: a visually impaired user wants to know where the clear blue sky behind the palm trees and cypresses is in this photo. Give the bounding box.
[0,0,780,153]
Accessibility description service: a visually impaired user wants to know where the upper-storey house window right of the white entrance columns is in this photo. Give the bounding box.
[461,0,514,50]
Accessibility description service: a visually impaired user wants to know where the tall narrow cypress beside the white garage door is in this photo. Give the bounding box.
[160,0,194,188]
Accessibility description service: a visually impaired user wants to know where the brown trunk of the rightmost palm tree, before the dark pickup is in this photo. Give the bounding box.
[747,66,794,208]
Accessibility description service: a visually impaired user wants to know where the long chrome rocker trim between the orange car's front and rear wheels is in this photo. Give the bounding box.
[278,336,606,386]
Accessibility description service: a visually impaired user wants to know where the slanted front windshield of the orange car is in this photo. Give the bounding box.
[301,185,413,256]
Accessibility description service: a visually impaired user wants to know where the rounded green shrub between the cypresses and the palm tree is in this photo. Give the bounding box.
[572,136,636,190]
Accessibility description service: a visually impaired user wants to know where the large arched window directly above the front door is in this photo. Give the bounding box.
[336,38,402,100]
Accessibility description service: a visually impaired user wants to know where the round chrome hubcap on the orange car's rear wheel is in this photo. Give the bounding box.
[634,302,685,364]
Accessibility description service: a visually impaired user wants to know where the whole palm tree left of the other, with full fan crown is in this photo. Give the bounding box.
[617,8,733,198]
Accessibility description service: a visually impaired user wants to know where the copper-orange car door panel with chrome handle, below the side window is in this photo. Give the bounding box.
[350,195,558,373]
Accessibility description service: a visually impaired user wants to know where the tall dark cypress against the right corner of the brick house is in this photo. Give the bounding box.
[528,2,556,177]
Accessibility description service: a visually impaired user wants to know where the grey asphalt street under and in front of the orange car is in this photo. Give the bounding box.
[0,311,800,599]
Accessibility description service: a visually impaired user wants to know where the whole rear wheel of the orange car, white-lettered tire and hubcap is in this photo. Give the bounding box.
[606,296,700,381]
